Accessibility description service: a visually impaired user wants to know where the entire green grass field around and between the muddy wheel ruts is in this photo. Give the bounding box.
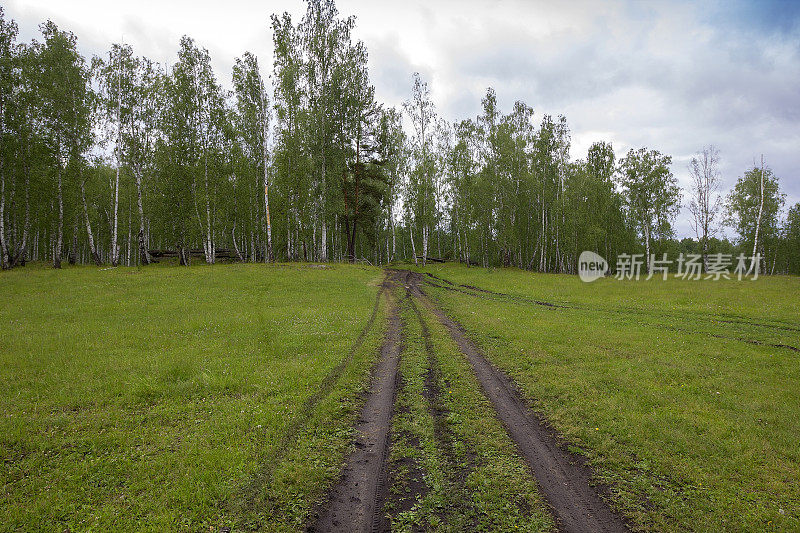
[0,264,800,532]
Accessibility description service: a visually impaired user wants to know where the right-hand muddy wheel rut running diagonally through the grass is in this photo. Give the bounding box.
[403,272,629,532]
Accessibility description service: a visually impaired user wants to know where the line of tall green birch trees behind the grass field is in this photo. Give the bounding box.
[0,0,800,273]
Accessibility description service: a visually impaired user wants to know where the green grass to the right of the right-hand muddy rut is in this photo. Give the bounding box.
[416,265,800,531]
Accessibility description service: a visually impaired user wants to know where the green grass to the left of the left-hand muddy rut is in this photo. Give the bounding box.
[0,265,385,531]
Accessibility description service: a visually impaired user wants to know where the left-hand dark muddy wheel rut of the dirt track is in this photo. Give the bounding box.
[309,274,403,533]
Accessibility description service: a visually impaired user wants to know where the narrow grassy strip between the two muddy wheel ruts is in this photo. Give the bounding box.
[388,288,553,532]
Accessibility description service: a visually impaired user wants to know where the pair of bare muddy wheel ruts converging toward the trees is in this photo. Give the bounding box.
[308,271,629,533]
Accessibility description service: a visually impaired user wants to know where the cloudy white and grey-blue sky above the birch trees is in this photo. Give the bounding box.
[2,0,800,236]
